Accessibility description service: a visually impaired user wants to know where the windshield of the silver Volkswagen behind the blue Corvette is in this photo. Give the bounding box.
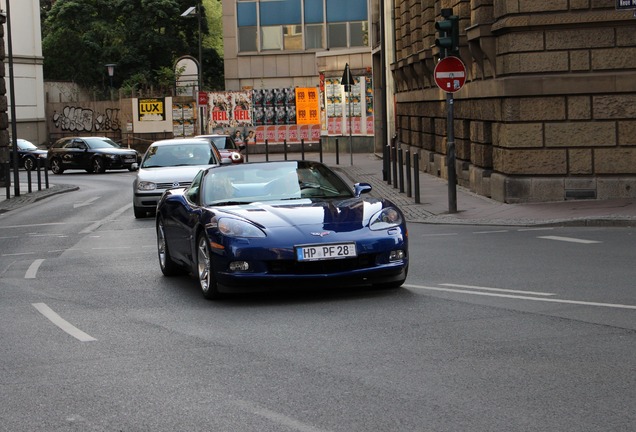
[141,141,217,168]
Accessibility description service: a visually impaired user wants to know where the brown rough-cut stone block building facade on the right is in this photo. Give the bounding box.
[385,0,636,203]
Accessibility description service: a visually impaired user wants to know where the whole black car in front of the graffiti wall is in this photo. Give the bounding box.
[47,137,141,174]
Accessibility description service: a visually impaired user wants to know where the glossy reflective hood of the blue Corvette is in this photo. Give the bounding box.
[215,197,391,232]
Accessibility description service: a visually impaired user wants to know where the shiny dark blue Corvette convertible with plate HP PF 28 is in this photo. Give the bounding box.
[156,161,408,299]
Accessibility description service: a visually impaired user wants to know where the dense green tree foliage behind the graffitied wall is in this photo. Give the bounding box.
[41,0,223,92]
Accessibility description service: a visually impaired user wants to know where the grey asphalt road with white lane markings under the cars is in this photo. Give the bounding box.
[0,171,636,432]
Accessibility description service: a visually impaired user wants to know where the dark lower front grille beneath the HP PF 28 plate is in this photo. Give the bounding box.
[267,254,375,275]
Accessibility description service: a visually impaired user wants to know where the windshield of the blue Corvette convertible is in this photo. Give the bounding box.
[202,161,353,205]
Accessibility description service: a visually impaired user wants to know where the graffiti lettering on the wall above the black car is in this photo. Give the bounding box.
[53,106,121,132]
